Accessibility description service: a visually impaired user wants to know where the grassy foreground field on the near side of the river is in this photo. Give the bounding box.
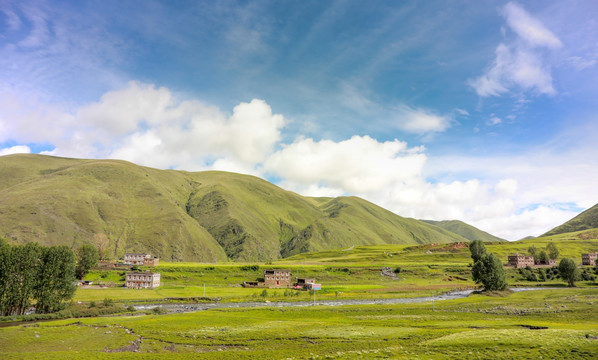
[0,289,598,359]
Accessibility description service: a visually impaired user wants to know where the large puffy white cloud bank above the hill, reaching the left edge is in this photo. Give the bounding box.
[0,82,285,172]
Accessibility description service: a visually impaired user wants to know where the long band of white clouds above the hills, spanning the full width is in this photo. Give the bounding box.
[0,82,598,240]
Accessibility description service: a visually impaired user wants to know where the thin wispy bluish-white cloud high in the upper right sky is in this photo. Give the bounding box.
[468,2,562,97]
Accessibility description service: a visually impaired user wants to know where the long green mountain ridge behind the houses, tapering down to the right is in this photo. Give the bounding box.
[0,154,466,262]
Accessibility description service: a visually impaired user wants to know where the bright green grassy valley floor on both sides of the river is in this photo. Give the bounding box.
[0,232,598,359]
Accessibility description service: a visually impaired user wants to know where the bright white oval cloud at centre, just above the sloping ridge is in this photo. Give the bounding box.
[264,136,426,194]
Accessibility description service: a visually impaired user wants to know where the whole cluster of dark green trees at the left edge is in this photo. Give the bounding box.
[0,238,97,316]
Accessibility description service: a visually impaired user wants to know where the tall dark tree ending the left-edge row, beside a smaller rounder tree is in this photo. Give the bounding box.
[34,246,76,313]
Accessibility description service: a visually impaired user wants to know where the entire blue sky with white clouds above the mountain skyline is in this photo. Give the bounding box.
[0,0,598,240]
